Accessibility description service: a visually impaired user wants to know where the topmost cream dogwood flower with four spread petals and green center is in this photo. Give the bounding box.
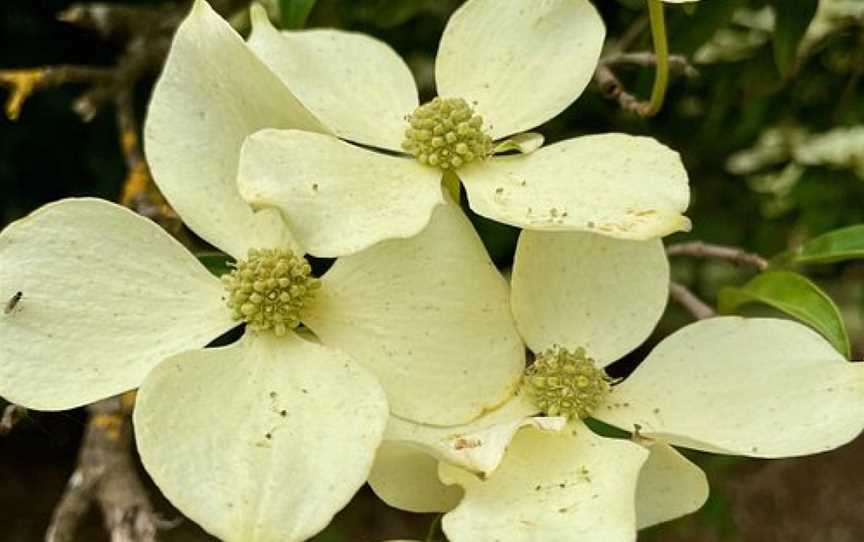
[204,0,689,256]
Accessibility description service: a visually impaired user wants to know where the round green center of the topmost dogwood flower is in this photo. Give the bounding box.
[402,98,492,169]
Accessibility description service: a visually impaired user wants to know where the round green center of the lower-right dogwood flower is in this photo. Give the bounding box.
[523,346,611,419]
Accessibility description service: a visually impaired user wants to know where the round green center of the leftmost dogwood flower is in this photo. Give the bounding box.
[222,248,321,337]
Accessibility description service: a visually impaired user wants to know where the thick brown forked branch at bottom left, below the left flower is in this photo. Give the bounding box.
[45,396,169,542]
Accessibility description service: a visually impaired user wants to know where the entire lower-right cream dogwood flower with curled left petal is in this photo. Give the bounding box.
[370,231,864,542]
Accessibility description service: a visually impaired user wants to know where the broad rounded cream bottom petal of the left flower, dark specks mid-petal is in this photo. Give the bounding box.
[135,334,387,542]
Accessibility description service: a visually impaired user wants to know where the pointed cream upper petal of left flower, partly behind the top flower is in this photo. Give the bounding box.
[144,0,324,257]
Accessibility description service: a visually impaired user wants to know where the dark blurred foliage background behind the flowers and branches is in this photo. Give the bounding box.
[0,0,864,542]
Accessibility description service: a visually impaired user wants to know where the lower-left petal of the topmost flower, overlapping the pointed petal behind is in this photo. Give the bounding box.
[239,130,444,257]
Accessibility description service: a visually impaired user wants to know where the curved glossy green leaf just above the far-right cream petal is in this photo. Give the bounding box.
[718,271,851,359]
